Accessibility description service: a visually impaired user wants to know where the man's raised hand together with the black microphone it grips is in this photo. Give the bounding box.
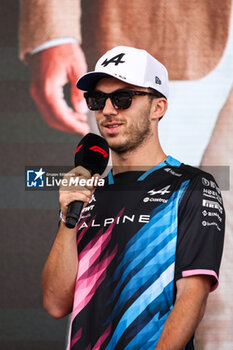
[60,133,109,228]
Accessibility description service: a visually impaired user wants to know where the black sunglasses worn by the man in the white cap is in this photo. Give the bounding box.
[84,89,162,111]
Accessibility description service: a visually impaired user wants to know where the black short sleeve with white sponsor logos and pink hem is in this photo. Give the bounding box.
[175,172,225,290]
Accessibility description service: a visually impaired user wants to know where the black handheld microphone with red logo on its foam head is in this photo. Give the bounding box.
[65,133,109,228]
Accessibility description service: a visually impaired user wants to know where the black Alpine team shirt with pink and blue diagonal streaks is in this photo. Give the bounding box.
[68,156,224,350]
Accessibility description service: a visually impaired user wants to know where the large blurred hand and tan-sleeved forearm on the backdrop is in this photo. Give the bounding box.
[19,0,89,135]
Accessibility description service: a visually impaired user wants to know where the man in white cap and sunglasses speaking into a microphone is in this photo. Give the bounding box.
[42,46,224,350]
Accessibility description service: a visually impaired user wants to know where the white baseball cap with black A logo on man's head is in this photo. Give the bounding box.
[76,46,169,98]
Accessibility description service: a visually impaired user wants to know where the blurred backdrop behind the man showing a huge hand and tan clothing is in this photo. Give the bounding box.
[0,0,233,350]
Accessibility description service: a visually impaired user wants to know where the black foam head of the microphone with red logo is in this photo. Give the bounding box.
[75,133,109,175]
